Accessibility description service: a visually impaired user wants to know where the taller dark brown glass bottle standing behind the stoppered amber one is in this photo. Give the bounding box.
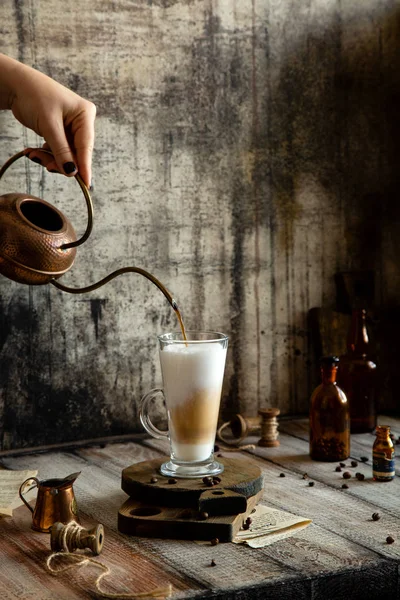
[337,308,376,433]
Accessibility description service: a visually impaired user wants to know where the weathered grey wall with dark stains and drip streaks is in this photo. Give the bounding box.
[0,0,400,448]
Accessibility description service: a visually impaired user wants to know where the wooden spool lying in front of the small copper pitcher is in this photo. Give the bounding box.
[51,521,104,554]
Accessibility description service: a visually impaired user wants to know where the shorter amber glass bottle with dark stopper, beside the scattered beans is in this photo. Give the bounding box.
[310,356,350,461]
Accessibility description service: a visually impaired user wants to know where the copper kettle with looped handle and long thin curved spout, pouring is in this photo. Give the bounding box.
[0,148,186,340]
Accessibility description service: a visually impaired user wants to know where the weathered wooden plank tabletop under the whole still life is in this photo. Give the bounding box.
[0,418,400,600]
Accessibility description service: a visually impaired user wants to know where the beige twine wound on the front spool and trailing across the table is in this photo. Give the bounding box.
[46,521,172,600]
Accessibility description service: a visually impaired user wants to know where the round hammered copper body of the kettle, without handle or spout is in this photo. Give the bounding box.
[0,193,76,284]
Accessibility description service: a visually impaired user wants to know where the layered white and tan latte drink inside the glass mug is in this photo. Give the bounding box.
[160,342,226,461]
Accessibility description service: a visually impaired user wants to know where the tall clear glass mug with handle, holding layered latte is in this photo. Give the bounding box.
[140,331,228,478]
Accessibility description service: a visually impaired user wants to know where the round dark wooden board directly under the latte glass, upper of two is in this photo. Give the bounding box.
[121,457,263,507]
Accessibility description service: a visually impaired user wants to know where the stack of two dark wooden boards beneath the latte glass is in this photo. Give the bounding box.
[118,457,263,542]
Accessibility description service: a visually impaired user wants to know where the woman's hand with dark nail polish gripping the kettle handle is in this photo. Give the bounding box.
[0,54,96,187]
